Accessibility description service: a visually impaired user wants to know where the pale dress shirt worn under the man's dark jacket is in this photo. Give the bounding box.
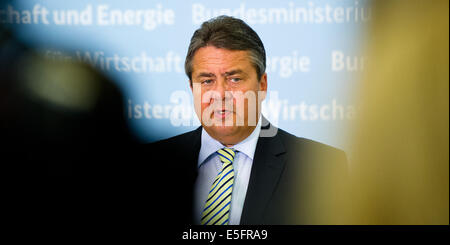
[194,117,261,225]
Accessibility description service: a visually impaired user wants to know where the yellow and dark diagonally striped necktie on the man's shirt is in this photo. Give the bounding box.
[201,148,236,225]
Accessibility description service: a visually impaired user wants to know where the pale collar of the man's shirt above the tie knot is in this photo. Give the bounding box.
[198,115,261,167]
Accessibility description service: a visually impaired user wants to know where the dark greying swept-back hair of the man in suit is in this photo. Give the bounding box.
[184,15,266,82]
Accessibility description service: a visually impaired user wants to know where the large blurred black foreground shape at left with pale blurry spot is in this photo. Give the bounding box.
[0,21,161,236]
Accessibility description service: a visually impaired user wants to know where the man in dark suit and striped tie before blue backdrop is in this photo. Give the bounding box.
[148,16,346,225]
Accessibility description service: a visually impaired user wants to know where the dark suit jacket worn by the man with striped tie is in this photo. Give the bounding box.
[148,119,347,224]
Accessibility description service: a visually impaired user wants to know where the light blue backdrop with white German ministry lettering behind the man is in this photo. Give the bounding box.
[0,0,371,149]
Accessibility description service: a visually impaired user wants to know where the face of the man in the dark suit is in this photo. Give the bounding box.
[191,46,267,146]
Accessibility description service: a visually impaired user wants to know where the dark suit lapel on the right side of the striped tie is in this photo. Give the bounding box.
[241,126,286,224]
